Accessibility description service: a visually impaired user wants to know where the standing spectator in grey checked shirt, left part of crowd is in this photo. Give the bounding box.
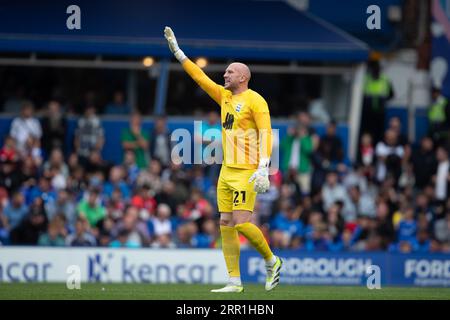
[74,104,105,165]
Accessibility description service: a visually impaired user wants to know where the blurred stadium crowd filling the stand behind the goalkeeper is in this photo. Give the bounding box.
[0,97,450,252]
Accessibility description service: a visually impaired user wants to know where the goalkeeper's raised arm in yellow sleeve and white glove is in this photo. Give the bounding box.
[164,27,221,105]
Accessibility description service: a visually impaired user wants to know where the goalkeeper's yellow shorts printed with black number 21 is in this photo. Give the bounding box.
[217,165,256,212]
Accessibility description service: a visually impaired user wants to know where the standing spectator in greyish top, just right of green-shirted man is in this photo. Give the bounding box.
[150,117,172,168]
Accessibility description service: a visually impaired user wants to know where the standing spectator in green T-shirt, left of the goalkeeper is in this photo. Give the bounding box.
[121,112,149,169]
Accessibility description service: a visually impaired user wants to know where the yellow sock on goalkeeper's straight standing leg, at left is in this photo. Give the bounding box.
[220,226,241,277]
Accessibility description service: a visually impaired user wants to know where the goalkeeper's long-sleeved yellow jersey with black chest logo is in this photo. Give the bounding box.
[183,59,272,169]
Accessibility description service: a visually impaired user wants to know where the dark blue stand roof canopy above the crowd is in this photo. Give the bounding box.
[0,0,368,62]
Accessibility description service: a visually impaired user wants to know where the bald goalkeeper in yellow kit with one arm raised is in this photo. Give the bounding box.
[164,27,282,292]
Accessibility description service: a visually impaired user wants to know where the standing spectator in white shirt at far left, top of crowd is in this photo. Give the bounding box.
[9,101,42,155]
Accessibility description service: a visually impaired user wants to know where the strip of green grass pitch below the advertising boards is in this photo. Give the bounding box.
[0,283,450,300]
